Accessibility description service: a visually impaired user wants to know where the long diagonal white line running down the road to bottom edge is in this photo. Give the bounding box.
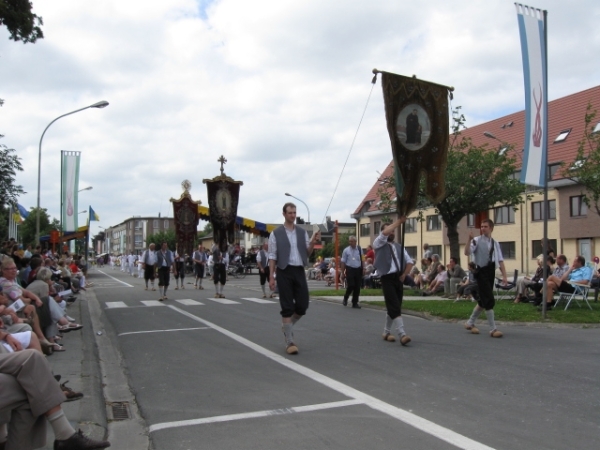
[167,305,493,450]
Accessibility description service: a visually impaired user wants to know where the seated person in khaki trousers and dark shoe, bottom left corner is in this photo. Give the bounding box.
[0,350,110,450]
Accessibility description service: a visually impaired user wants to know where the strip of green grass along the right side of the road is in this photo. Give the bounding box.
[310,289,600,324]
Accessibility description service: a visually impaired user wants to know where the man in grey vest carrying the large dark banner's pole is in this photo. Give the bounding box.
[373,216,414,345]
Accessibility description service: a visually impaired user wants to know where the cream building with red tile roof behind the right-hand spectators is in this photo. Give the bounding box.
[352,86,600,278]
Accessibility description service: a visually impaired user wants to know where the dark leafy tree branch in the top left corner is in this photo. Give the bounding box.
[0,0,44,44]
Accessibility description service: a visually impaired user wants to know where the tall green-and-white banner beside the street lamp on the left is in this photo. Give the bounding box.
[60,150,81,231]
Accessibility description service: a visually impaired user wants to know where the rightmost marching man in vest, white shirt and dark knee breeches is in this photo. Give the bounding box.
[465,219,507,338]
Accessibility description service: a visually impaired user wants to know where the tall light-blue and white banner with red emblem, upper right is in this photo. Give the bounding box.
[515,3,548,186]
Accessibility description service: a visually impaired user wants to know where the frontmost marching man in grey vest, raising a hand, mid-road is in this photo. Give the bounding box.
[269,203,321,355]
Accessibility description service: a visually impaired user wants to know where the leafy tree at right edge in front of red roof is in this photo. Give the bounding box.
[562,104,600,215]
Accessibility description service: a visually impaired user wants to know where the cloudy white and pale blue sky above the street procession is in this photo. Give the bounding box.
[0,0,600,239]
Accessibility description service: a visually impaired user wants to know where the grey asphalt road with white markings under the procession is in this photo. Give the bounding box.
[93,268,600,450]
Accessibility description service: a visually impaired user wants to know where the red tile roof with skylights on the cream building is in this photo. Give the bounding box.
[354,86,600,214]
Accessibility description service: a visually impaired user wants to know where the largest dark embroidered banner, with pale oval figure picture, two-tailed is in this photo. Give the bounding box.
[373,69,453,216]
